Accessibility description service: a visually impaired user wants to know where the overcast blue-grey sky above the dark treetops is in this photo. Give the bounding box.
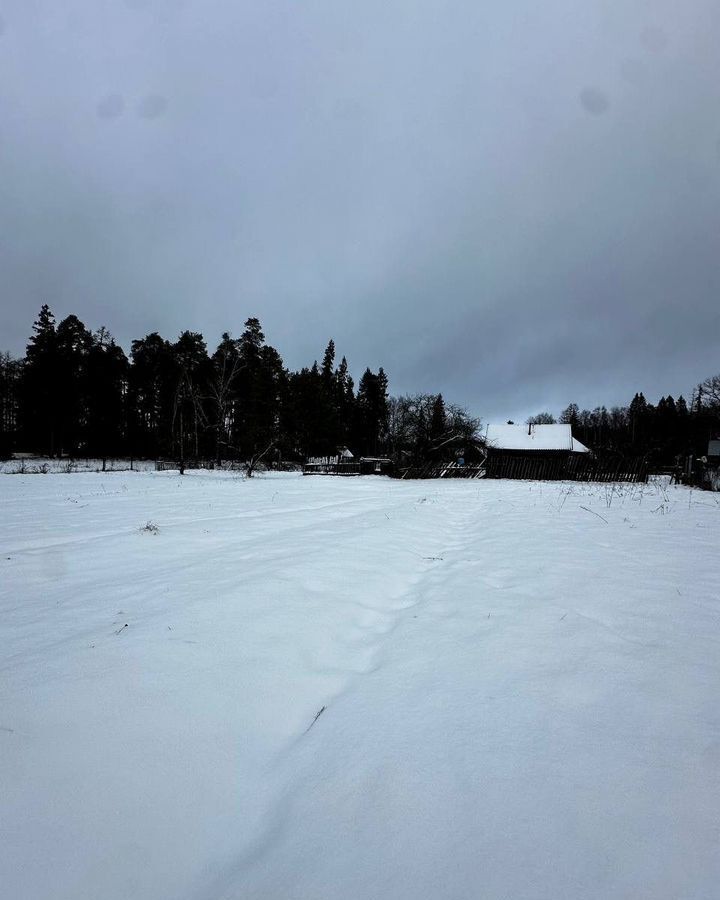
[0,0,720,420]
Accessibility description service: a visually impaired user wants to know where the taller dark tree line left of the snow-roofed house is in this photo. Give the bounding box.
[0,305,479,468]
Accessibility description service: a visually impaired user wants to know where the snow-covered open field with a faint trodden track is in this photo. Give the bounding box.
[0,472,720,900]
